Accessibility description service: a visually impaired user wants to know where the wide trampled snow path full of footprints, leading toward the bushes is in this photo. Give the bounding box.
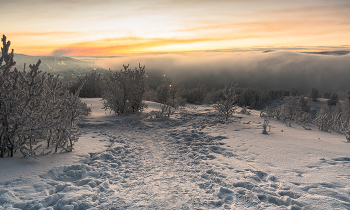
[0,110,350,210]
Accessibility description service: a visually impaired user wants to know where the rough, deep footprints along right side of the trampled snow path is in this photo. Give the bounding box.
[170,129,303,210]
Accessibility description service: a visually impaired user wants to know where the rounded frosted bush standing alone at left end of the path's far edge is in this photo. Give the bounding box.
[102,64,146,115]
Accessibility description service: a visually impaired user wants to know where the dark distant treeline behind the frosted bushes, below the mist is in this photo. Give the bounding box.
[69,71,339,109]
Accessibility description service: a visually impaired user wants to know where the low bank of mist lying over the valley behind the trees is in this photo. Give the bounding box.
[96,51,350,94]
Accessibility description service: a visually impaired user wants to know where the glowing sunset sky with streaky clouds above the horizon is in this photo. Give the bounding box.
[0,0,350,56]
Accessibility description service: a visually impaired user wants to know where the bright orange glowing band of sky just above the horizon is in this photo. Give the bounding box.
[8,34,350,56]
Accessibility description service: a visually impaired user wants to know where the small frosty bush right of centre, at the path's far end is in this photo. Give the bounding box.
[214,84,237,121]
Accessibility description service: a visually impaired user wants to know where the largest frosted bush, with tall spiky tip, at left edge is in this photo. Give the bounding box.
[0,35,89,157]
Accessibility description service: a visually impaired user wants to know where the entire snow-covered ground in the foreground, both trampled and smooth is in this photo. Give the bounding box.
[0,99,350,210]
